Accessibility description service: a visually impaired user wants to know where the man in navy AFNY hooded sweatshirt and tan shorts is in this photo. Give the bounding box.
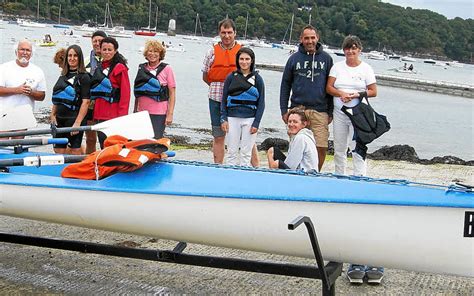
[280,25,333,171]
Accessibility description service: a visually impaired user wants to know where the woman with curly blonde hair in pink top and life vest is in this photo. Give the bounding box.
[133,40,176,139]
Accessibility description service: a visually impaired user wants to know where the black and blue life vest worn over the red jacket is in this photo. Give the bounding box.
[90,64,120,103]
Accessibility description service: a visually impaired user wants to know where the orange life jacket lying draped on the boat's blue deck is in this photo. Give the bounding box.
[61,135,170,180]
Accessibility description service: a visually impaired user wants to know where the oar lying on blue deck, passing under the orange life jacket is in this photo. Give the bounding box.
[0,151,176,167]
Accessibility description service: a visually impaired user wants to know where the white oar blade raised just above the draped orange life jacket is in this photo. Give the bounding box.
[92,111,155,140]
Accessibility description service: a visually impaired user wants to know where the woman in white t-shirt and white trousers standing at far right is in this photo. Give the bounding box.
[326,35,384,284]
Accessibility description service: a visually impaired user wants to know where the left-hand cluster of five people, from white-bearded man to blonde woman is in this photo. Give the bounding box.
[0,31,176,154]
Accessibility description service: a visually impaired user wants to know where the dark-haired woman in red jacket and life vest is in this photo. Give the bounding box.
[91,37,130,149]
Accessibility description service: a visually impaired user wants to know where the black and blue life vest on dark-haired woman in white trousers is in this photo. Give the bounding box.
[227,71,260,109]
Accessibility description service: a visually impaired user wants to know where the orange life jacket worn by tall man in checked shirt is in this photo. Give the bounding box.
[207,43,242,82]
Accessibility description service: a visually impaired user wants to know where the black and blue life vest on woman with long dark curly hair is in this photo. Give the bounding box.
[52,75,80,111]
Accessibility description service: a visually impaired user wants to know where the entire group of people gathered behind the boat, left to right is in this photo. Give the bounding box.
[0,19,383,282]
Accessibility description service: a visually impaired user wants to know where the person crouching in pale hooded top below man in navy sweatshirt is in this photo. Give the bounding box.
[267,108,318,172]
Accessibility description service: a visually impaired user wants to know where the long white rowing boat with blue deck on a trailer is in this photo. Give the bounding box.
[0,150,474,277]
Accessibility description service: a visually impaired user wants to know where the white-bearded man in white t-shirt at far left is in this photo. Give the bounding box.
[0,40,46,138]
